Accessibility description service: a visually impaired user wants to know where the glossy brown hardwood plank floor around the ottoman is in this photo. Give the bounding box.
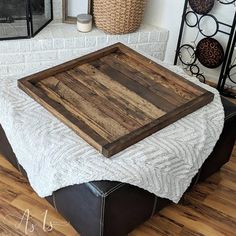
[0,97,236,236]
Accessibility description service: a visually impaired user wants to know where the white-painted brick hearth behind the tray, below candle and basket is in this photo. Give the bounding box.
[0,22,168,78]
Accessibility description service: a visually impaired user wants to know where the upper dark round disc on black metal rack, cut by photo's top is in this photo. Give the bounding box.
[189,0,215,15]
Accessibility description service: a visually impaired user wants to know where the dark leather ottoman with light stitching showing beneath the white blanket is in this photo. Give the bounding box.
[0,98,236,236]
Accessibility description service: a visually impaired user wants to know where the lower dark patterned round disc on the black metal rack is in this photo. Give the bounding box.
[196,38,224,69]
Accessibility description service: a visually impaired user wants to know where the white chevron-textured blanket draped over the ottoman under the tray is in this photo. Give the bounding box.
[0,58,224,203]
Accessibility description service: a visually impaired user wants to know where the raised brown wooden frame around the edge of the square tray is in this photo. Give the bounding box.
[18,43,214,157]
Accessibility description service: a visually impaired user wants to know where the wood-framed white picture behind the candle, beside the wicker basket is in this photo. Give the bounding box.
[62,0,91,24]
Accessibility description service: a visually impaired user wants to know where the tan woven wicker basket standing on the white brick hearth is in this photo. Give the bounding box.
[93,0,146,34]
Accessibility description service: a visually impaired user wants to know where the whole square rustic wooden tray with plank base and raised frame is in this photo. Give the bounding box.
[18,43,214,157]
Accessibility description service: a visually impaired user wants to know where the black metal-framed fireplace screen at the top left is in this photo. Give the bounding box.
[0,0,53,40]
